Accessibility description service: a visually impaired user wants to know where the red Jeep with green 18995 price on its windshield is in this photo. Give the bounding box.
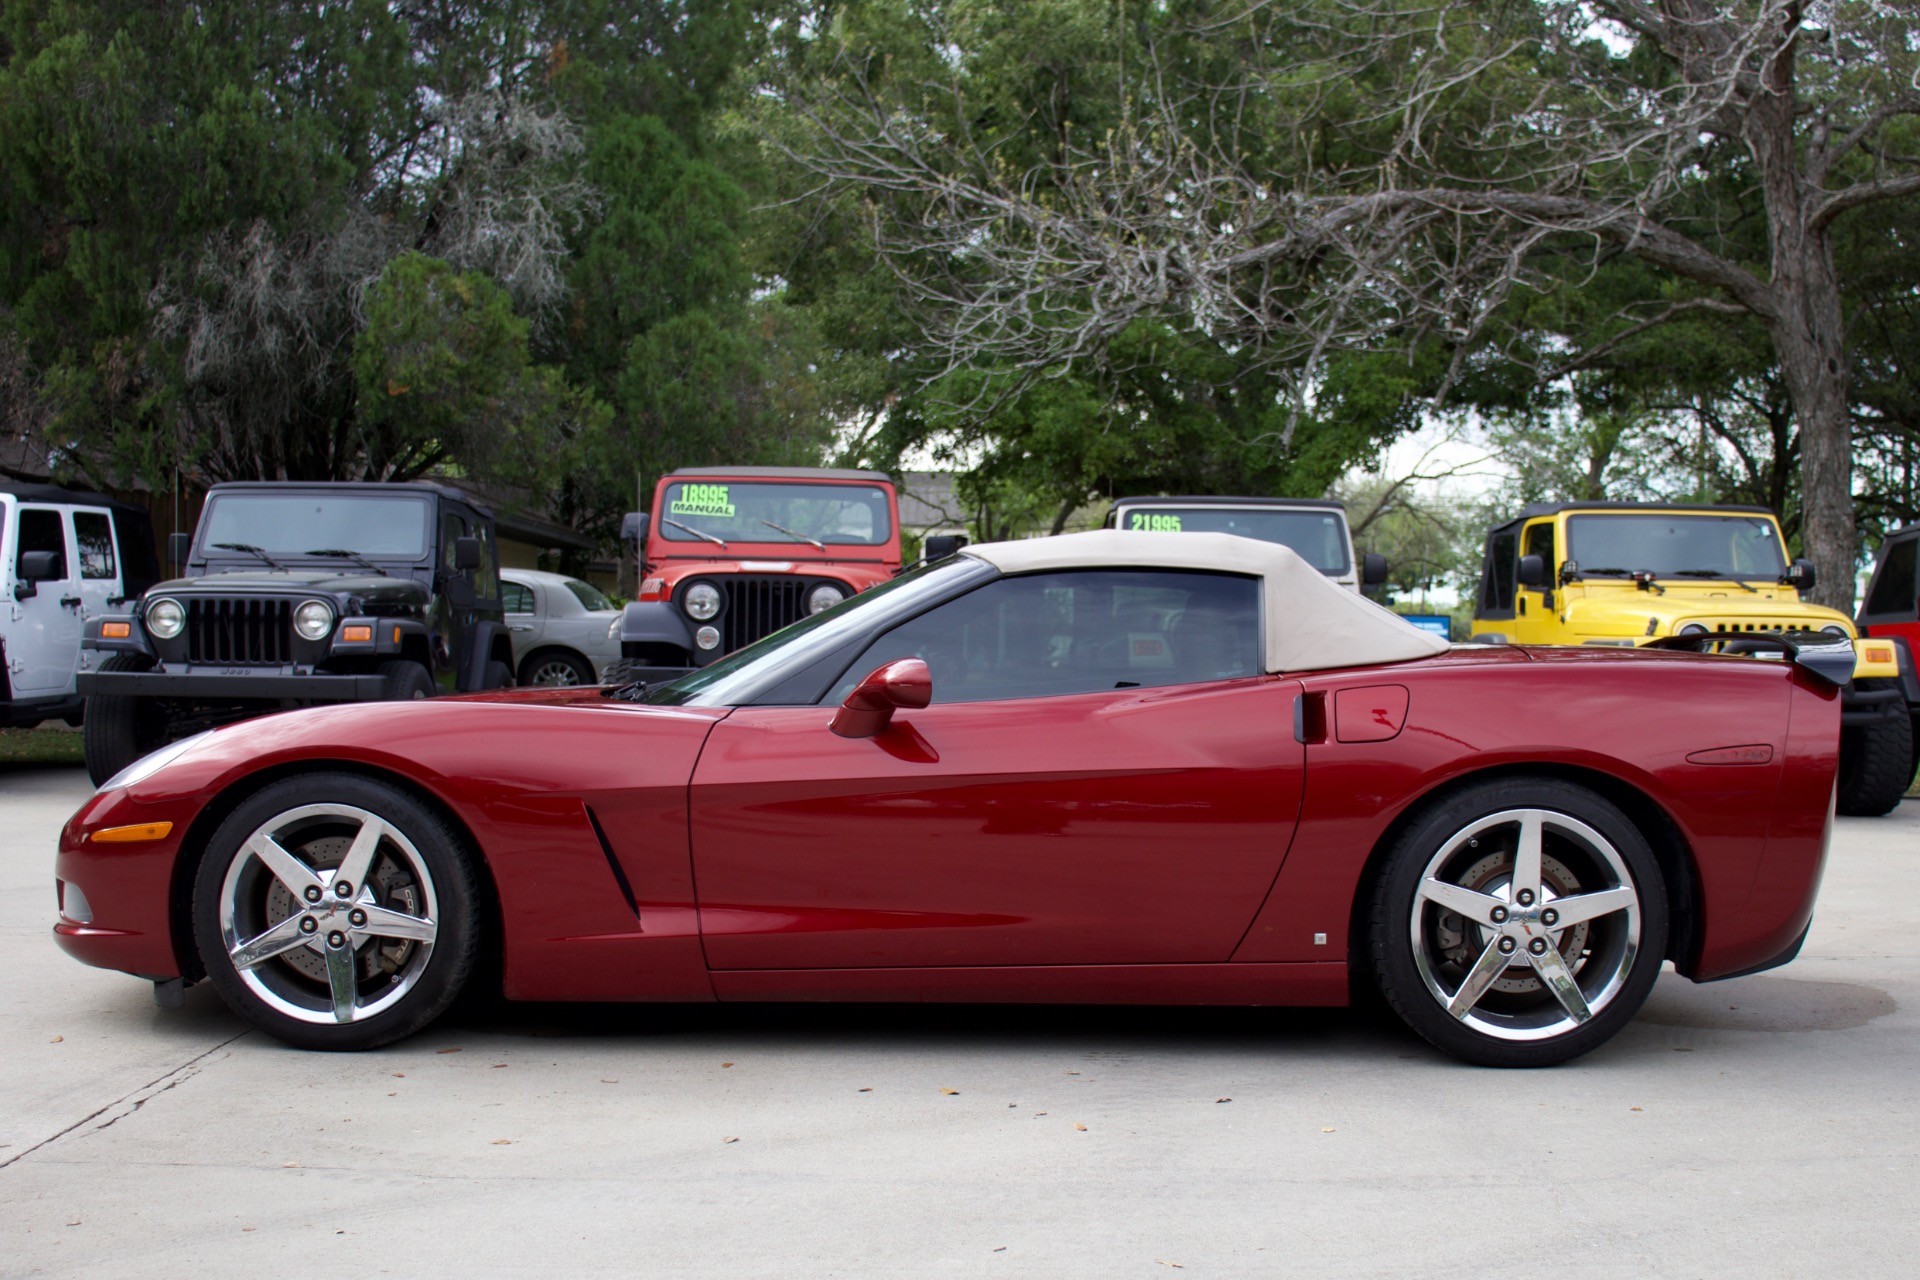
[620,466,900,683]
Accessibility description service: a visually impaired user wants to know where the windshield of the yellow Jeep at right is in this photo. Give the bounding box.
[1567,512,1788,580]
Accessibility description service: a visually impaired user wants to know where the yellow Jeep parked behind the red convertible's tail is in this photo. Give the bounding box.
[1473,503,1920,814]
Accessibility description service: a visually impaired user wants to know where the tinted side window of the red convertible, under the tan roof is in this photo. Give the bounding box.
[828,570,1260,702]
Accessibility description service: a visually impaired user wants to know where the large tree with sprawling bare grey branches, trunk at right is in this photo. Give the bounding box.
[771,0,1920,603]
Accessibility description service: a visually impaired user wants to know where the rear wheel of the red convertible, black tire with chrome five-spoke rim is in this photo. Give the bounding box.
[1367,777,1667,1067]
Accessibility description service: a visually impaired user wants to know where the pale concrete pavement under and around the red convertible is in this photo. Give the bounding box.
[0,756,1920,1278]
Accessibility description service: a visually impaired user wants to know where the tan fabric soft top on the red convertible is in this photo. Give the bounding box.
[964,530,1450,672]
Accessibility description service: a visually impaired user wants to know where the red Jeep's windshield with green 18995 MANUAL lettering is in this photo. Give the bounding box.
[659,480,893,547]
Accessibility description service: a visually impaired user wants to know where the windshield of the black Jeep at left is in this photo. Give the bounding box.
[200,493,430,560]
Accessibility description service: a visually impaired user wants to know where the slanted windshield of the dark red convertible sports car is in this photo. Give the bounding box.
[641,555,998,706]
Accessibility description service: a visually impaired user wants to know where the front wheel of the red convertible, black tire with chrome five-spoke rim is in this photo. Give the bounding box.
[192,773,480,1050]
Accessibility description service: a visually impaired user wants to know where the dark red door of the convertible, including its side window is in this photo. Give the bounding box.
[691,570,1304,969]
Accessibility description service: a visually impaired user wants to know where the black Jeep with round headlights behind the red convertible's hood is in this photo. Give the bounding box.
[79,482,513,783]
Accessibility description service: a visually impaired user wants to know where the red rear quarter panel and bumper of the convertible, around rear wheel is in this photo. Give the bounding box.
[1235,647,1839,979]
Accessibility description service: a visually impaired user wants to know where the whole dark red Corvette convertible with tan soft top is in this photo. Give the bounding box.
[54,532,1851,1065]
